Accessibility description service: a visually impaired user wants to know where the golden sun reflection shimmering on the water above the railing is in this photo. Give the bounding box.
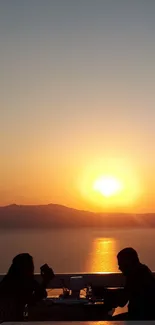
[86,237,118,273]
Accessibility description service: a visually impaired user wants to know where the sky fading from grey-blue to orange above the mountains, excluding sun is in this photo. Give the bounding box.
[0,0,155,213]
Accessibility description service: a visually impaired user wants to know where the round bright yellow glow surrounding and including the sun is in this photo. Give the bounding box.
[78,159,143,212]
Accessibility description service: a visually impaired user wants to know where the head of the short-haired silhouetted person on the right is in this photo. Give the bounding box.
[117,247,140,275]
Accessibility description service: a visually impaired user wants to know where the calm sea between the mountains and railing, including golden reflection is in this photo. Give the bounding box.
[0,229,155,273]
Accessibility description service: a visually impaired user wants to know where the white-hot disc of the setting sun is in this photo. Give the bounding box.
[93,176,122,197]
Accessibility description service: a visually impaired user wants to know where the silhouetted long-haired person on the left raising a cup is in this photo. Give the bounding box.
[0,253,54,320]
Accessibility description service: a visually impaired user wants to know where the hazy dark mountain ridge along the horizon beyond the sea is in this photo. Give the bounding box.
[0,204,155,229]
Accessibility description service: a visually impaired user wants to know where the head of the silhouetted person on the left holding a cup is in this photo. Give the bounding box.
[9,253,34,279]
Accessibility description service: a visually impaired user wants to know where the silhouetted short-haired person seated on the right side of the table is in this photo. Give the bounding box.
[105,247,155,320]
